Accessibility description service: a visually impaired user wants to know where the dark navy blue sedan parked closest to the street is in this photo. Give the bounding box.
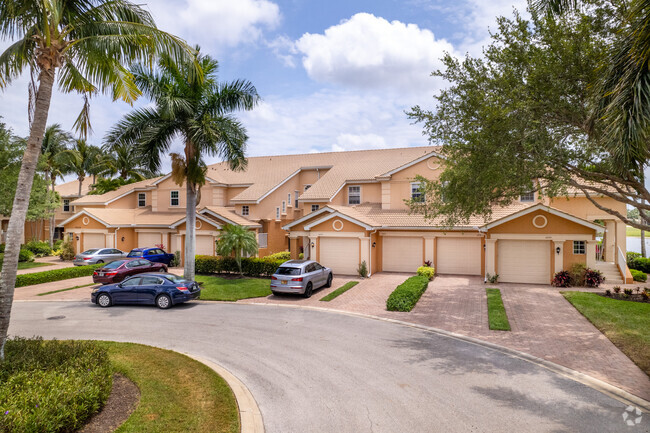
[90,272,201,309]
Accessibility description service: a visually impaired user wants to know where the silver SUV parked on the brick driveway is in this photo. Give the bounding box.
[271,260,333,298]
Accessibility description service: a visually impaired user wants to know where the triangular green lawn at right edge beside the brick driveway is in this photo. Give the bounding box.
[562,292,650,376]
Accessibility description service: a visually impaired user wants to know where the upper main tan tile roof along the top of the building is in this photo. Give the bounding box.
[207,146,440,202]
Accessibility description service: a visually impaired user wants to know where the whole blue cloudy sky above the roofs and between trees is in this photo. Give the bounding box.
[0,0,526,173]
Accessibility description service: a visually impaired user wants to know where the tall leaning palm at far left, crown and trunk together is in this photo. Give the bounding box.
[0,0,196,360]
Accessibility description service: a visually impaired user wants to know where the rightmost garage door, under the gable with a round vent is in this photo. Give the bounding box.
[497,239,551,284]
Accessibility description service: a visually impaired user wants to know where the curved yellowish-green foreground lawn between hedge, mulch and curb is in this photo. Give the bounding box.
[98,342,235,433]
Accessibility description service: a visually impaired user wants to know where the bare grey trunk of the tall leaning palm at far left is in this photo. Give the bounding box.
[0,70,54,360]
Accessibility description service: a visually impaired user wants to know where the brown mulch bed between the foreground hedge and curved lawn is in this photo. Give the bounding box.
[78,374,140,433]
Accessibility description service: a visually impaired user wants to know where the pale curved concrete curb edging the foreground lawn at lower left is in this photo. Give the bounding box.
[181,352,264,433]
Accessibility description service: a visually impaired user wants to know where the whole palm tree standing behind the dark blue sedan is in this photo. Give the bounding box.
[106,48,259,279]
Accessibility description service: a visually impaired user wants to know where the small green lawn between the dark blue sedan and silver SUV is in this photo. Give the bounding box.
[196,275,271,301]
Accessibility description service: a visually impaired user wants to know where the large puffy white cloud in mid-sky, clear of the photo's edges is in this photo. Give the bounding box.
[295,13,455,92]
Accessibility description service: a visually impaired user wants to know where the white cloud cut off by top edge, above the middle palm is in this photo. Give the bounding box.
[154,0,281,50]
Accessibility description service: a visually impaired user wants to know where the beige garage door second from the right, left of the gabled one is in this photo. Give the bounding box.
[436,238,483,275]
